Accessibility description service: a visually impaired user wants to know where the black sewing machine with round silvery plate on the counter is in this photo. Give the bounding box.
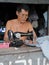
[8,30,33,47]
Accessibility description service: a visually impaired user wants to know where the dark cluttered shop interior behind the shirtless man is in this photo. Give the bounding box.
[0,3,48,40]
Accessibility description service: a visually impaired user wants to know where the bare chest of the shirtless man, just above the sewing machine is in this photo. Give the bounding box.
[11,24,28,32]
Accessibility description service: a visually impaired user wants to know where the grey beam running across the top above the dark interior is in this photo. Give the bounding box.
[0,0,49,4]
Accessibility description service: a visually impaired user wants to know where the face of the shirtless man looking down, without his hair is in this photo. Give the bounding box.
[17,9,28,22]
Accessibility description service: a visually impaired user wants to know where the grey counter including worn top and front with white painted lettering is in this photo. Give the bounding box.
[0,46,49,65]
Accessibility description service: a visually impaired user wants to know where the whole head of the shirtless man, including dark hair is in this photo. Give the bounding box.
[16,5,29,22]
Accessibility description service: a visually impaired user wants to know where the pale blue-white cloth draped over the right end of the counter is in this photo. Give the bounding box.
[37,36,49,60]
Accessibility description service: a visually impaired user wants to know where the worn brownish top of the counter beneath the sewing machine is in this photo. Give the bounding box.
[0,46,41,55]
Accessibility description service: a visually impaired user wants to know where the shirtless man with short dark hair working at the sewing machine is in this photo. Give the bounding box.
[4,5,36,41]
